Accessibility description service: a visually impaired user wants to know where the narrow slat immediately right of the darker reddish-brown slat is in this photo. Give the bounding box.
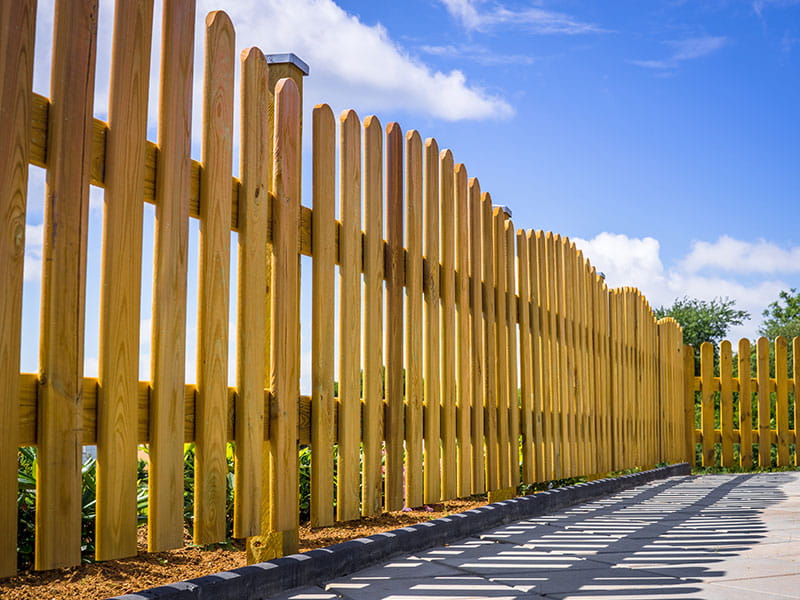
[405,131,424,506]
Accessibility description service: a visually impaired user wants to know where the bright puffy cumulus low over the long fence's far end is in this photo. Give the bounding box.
[573,232,800,338]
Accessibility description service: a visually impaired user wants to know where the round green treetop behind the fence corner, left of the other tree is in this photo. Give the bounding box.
[654,296,750,351]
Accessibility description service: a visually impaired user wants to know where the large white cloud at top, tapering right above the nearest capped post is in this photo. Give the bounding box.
[198,0,513,120]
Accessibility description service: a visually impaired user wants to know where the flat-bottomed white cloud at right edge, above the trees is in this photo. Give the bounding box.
[682,235,800,273]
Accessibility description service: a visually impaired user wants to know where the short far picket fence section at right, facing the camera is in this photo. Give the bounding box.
[686,337,800,469]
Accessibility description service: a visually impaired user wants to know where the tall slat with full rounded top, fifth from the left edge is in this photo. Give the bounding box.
[194,11,234,544]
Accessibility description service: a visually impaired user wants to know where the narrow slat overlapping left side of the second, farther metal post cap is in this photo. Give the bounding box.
[492,207,511,489]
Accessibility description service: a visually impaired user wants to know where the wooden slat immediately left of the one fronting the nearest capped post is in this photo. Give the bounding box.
[233,48,271,538]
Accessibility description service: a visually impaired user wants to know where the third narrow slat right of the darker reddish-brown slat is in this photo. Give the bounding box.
[439,150,457,498]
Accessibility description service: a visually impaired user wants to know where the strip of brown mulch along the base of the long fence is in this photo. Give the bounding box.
[0,496,486,600]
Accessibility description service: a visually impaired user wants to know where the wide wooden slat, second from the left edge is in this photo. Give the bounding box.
[34,0,97,570]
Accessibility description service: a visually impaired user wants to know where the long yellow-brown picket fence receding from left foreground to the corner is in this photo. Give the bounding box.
[0,0,692,576]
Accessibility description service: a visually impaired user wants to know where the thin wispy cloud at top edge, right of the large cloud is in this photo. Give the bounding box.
[441,0,605,35]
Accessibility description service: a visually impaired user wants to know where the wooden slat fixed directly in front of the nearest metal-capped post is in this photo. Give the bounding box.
[269,79,302,554]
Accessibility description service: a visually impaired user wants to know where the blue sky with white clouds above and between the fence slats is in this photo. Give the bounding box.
[18,0,800,384]
